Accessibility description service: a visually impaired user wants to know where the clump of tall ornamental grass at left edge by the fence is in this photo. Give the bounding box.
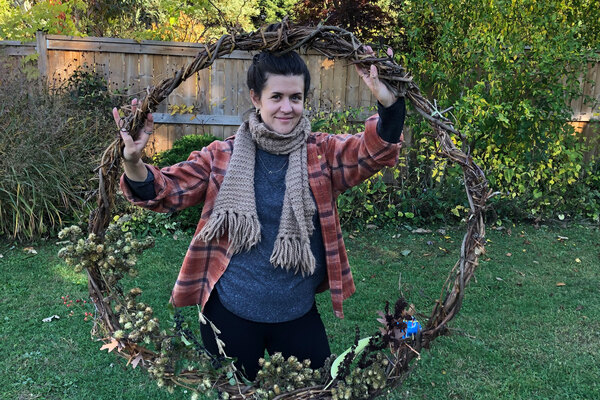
[0,64,114,239]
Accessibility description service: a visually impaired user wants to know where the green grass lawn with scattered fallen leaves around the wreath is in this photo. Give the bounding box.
[0,226,600,400]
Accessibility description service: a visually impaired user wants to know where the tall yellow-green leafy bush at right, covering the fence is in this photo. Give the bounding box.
[384,0,600,220]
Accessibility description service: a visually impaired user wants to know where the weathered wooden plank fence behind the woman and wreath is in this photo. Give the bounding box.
[0,33,600,152]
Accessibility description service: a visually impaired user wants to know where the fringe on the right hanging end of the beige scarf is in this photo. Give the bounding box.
[270,236,316,276]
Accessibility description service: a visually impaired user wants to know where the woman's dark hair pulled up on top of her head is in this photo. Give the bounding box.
[247,51,310,99]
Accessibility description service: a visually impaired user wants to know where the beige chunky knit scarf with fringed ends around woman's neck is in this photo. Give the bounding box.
[196,113,316,276]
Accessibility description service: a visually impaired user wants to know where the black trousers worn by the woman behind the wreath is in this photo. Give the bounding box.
[200,290,331,380]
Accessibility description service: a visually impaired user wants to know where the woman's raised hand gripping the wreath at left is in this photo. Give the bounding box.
[113,99,154,182]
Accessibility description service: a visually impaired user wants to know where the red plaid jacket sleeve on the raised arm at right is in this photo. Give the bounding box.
[325,111,402,196]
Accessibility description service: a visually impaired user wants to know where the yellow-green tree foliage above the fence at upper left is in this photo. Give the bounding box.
[0,0,262,41]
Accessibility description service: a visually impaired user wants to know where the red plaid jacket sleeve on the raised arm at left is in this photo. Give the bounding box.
[120,147,213,212]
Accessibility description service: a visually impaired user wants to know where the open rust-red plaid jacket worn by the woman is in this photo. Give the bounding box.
[121,116,400,318]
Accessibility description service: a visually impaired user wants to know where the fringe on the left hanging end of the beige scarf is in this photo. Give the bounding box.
[194,211,260,254]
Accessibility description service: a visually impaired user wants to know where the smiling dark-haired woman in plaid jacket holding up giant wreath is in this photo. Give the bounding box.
[113,48,405,380]
